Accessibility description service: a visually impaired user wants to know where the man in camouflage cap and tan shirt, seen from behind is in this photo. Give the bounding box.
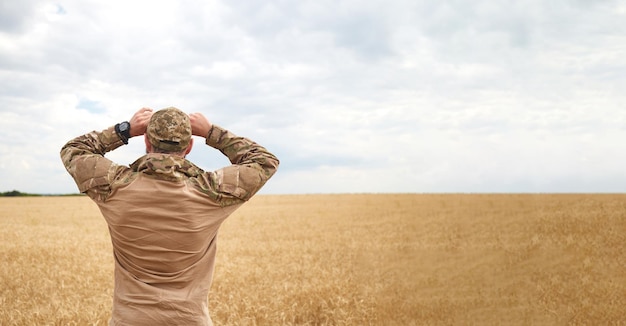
[61,108,279,326]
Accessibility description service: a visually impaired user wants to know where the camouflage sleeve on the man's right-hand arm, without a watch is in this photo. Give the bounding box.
[201,125,279,204]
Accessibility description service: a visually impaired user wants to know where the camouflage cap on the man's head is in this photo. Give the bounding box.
[146,107,191,153]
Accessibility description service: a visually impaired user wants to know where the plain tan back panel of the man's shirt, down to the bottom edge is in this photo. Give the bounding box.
[98,164,239,325]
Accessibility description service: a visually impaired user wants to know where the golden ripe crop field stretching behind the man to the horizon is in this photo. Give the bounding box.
[0,194,626,325]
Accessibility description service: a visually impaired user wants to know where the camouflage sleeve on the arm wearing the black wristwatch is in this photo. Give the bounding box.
[61,128,129,201]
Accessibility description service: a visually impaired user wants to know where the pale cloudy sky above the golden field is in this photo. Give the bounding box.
[0,0,626,194]
